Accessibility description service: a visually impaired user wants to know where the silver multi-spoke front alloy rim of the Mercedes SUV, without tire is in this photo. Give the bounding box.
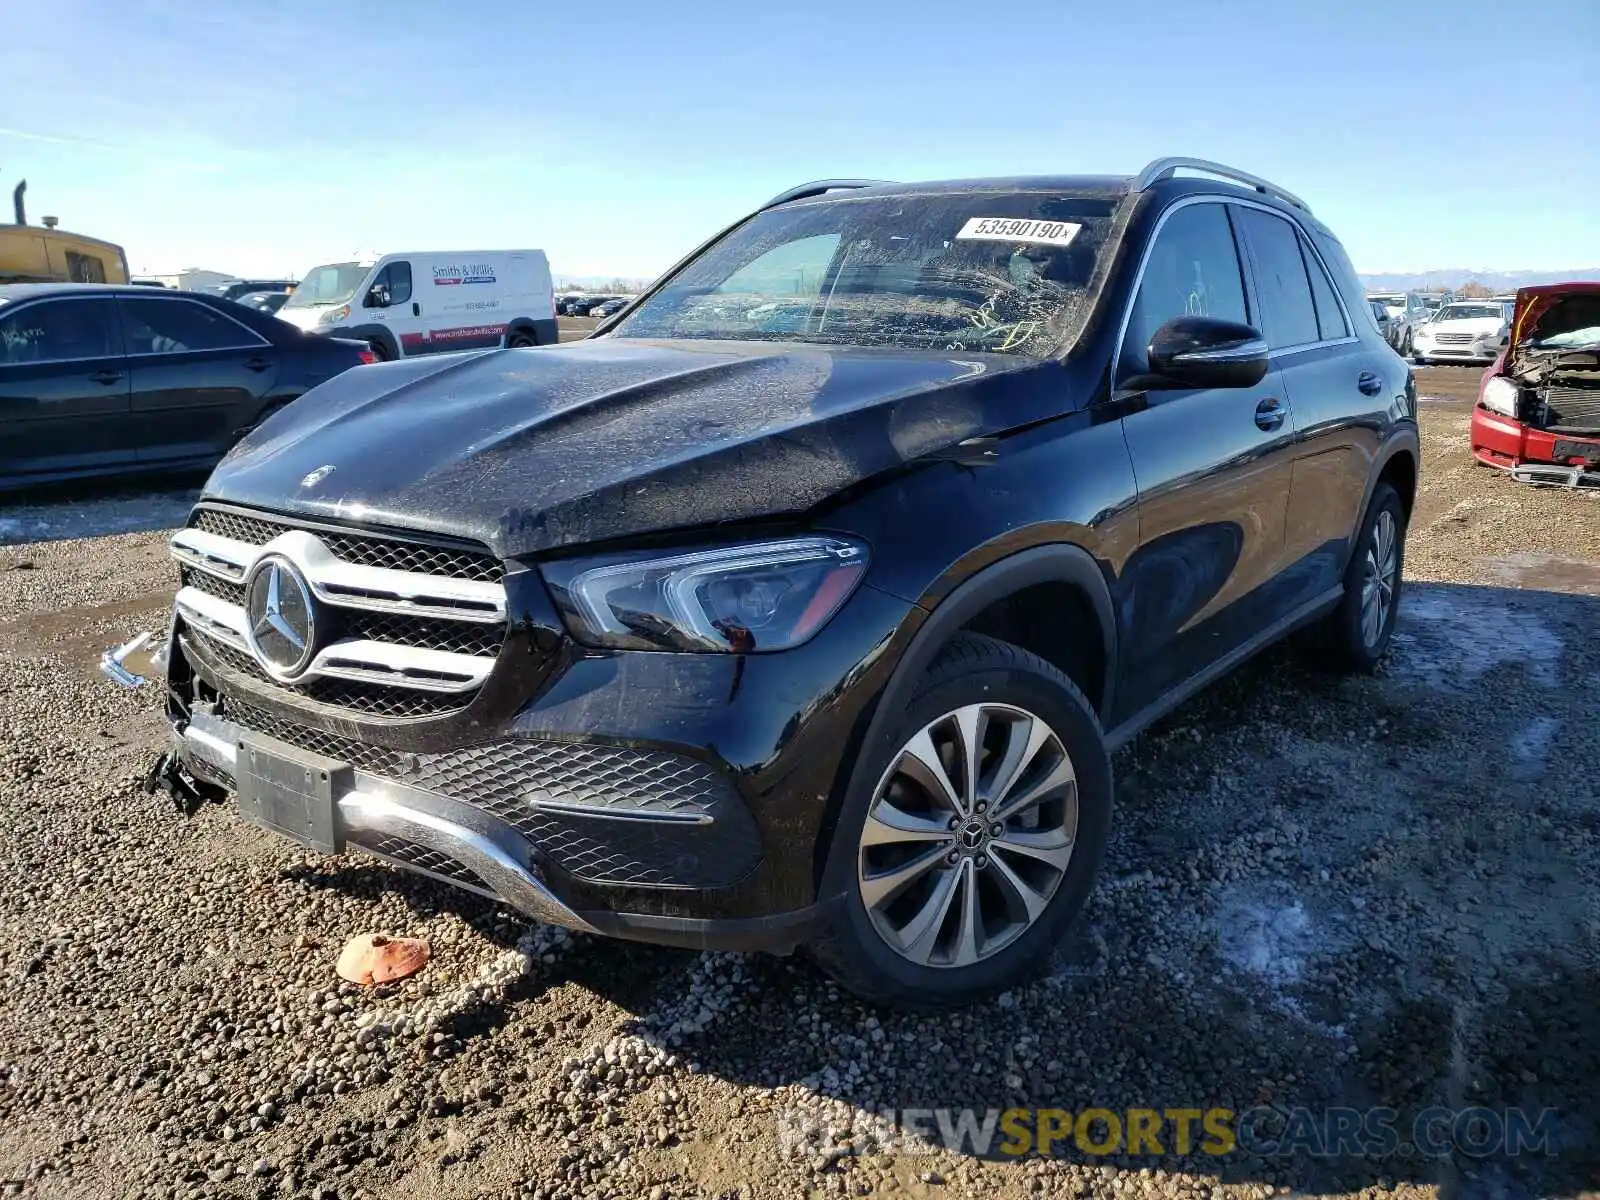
[856,704,1078,966]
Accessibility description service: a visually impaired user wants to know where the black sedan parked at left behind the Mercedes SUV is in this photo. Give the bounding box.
[0,283,373,488]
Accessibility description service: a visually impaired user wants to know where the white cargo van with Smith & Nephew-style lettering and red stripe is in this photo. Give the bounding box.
[278,250,558,358]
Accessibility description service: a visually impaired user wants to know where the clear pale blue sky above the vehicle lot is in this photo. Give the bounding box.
[0,0,1600,275]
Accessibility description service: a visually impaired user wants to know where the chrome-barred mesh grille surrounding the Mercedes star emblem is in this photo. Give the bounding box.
[173,509,506,718]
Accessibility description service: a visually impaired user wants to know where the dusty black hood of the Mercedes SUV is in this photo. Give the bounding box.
[205,338,1049,557]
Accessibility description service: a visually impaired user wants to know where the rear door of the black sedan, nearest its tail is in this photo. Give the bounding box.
[118,294,280,462]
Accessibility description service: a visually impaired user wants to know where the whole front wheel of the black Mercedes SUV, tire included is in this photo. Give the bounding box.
[808,634,1112,1011]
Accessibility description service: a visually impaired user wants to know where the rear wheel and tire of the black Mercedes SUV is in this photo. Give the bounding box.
[1307,483,1405,674]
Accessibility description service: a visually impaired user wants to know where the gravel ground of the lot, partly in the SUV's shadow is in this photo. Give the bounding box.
[0,368,1600,1200]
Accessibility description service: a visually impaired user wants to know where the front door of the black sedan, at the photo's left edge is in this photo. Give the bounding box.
[0,294,134,475]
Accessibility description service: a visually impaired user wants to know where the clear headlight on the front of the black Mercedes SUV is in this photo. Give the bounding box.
[541,538,867,653]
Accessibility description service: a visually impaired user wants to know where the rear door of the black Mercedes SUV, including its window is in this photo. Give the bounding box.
[1238,206,1397,603]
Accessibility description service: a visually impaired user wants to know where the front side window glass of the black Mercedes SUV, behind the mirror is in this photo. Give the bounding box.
[1122,203,1250,374]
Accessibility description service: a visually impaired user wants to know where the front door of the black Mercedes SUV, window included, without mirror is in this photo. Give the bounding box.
[1112,200,1294,723]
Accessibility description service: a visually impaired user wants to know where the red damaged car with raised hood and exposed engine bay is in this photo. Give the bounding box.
[1472,283,1600,488]
